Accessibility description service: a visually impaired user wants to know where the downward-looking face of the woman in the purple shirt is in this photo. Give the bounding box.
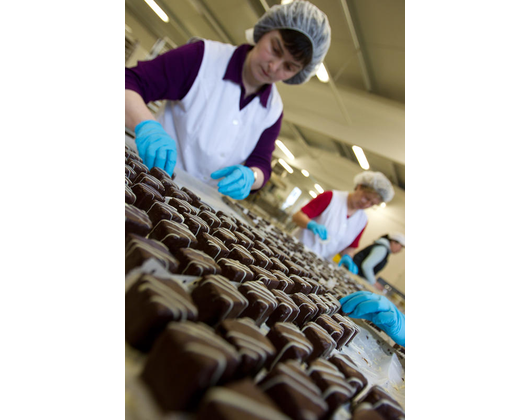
[247,31,303,85]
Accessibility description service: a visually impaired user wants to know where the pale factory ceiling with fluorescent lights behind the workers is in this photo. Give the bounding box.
[125,0,405,194]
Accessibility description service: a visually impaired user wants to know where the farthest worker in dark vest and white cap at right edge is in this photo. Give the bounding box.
[353,232,405,285]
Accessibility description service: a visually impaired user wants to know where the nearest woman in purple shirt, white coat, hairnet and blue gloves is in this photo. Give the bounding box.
[125,1,331,200]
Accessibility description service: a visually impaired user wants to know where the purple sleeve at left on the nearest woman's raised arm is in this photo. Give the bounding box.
[125,41,204,103]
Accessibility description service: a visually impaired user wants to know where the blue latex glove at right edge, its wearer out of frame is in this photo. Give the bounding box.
[339,292,405,347]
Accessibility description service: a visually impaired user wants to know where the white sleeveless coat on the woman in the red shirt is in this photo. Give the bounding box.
[295,191,368,261]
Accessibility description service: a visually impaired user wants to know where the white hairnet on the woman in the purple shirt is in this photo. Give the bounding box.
[247,0,331,85]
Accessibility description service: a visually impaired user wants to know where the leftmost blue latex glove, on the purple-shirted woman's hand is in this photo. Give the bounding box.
[134,120,177,176]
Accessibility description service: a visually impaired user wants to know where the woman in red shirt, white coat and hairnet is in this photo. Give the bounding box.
[293,171,394,274]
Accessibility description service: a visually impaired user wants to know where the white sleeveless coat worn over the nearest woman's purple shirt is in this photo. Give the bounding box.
[158,40,283,186]
